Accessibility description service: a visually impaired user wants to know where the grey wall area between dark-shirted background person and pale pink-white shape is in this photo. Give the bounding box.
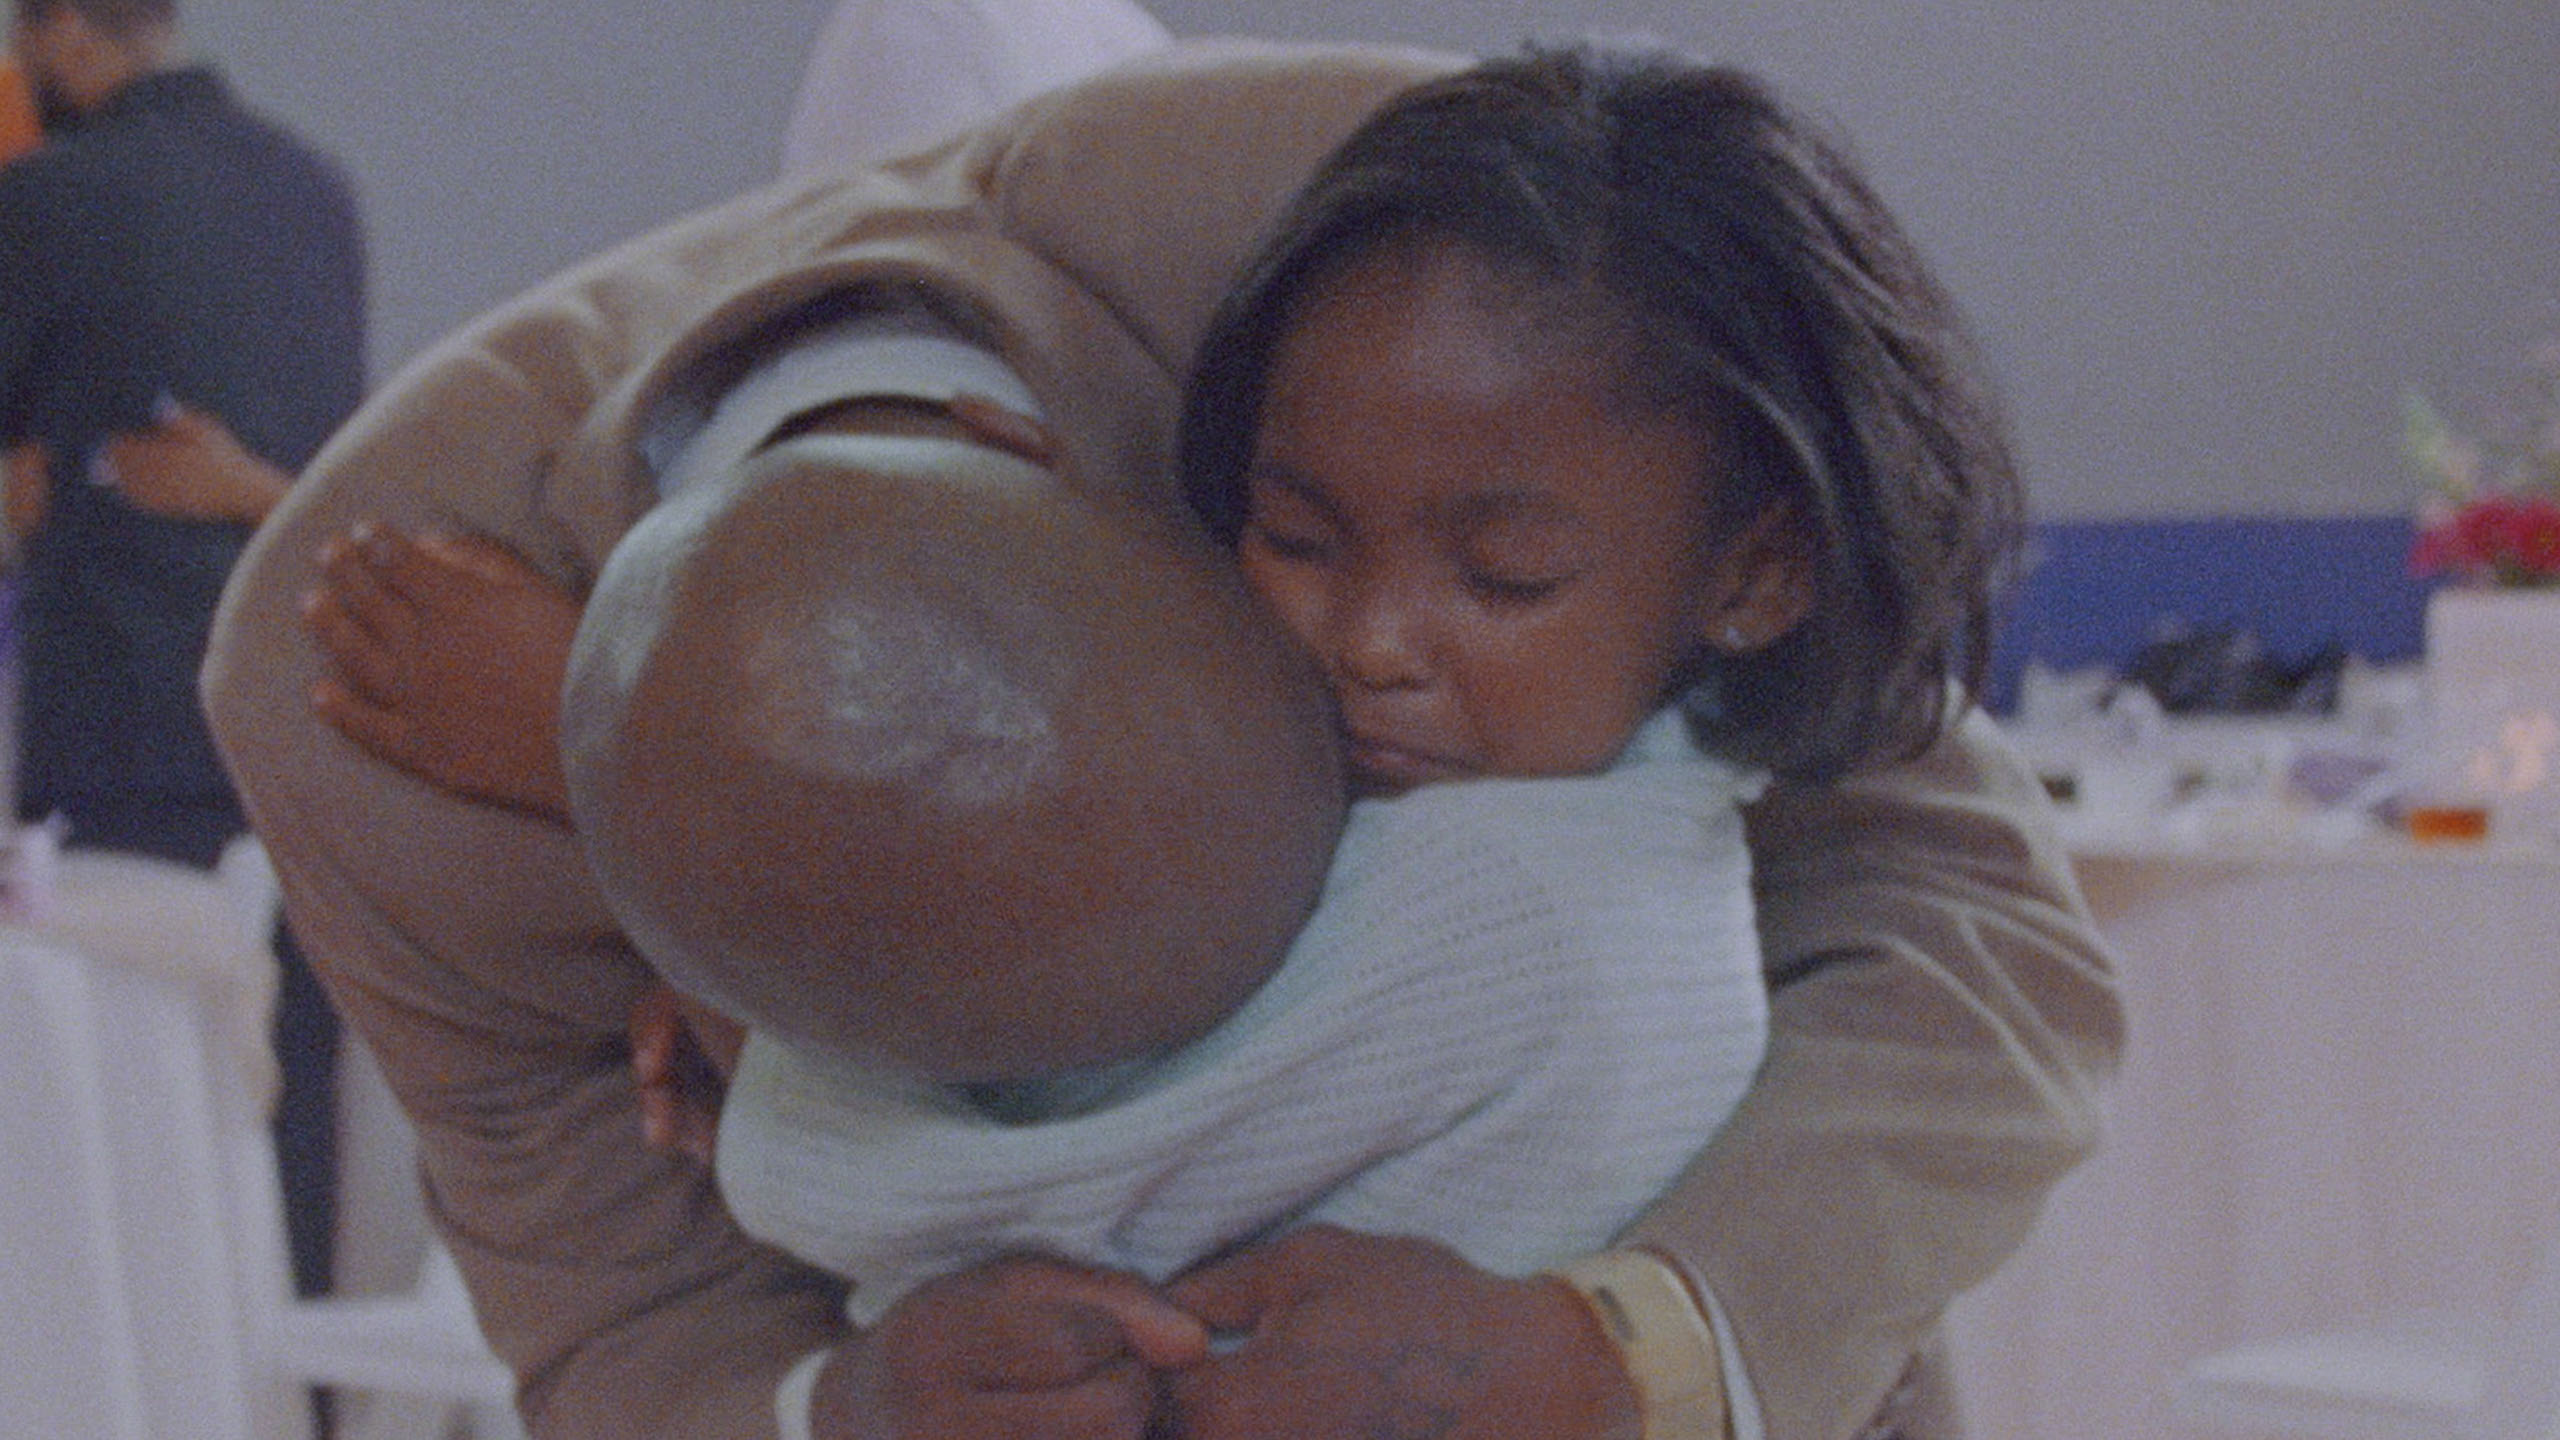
[179,0,827,382]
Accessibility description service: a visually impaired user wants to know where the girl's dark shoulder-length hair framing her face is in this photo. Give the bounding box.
[1180,46,2020,779]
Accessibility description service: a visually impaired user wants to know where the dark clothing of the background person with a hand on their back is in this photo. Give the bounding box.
[0,69,364,848]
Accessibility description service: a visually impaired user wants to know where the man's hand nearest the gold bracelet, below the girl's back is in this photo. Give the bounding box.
[1165,1227,1641,1440]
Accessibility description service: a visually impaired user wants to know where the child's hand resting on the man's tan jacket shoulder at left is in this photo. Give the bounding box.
[302,525,579,825]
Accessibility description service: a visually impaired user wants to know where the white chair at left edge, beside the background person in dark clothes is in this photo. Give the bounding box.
[0,843,522,1440]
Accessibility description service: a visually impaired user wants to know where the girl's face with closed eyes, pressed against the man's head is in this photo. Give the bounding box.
[1239,243,1725,794]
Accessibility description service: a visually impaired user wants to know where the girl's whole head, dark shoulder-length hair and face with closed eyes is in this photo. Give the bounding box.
[1185,51,2020,779]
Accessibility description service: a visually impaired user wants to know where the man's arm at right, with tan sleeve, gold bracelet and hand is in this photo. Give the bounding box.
[1178,717,2122,1440]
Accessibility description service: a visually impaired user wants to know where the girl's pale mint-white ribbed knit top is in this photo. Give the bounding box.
[719,712,1766,1322]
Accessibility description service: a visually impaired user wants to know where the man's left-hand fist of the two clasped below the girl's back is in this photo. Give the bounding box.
[812,1258,1208,1440]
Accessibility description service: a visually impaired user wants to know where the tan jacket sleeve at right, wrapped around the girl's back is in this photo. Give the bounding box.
[1626,712,2125,1440]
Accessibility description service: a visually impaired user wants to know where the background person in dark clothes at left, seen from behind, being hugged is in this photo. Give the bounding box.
[0,0,364,1291]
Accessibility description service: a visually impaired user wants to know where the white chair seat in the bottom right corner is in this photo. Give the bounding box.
[2179,1219,2560,1440]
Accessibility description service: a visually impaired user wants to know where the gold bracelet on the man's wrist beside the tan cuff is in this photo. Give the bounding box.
[1546,1250,1733,1440]
